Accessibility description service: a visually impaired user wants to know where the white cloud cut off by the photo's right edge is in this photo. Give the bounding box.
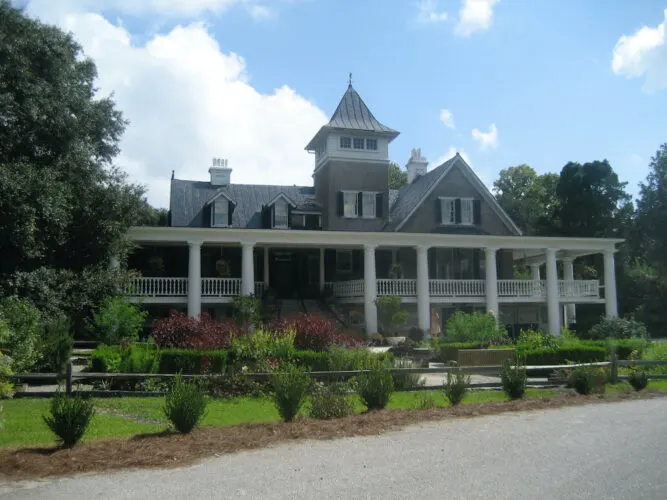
[611,9,667,92]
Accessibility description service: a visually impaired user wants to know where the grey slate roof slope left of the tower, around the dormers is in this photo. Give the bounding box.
[170,179,322,229]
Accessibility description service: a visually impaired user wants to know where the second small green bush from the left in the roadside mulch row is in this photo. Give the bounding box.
[164,374,206,434]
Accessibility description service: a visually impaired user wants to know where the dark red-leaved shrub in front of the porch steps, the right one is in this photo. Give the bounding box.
[268,313,360,351]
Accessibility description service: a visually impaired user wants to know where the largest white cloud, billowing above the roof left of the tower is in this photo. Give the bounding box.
[24,0,328,207]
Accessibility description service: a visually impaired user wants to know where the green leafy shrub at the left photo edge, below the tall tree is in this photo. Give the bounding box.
[0,295,42,373]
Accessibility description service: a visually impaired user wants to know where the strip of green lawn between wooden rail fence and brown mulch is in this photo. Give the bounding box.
[0,380,667,448]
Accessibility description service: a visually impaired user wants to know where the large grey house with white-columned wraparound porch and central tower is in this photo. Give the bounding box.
[127,85,621,335]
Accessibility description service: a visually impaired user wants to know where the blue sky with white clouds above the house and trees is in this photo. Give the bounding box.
[14,0,667,207]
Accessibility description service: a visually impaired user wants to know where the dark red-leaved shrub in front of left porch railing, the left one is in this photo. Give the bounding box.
[152,310,245,349]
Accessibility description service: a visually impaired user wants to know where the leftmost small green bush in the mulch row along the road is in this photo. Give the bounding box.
[43,393,95,448]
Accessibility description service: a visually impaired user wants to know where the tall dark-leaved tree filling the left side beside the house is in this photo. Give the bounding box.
[0,0,152,332]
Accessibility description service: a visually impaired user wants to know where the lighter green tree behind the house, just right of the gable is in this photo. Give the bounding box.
[493,164,558,235]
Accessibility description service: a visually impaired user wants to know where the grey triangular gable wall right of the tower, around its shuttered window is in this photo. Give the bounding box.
[396,161,521,236]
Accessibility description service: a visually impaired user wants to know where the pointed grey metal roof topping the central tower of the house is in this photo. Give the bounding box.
[306,83,400,151]
